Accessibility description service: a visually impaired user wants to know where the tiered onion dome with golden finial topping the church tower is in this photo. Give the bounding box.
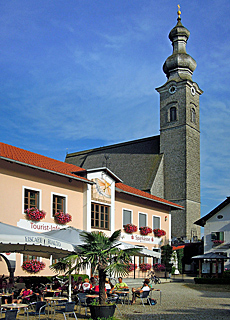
[163,6,196,80]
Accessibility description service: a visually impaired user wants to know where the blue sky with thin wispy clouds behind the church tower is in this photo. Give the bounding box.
[0,0,230,219]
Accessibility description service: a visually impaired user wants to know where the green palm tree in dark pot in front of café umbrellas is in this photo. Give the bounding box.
[53,230,140,319]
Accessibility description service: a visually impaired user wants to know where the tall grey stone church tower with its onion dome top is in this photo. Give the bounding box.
[156,11,203,239]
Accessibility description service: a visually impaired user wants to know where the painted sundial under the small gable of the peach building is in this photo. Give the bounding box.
[92,178,111,203]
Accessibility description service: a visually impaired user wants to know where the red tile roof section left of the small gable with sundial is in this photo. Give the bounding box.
[0,142,89,181]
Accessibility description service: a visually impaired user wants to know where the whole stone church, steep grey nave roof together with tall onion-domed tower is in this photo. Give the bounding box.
[65,11,202,240]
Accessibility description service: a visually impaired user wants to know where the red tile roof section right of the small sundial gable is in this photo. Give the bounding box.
[116,182,184,209]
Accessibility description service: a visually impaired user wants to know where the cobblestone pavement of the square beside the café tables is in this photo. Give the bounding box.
[20,279,230,320]
